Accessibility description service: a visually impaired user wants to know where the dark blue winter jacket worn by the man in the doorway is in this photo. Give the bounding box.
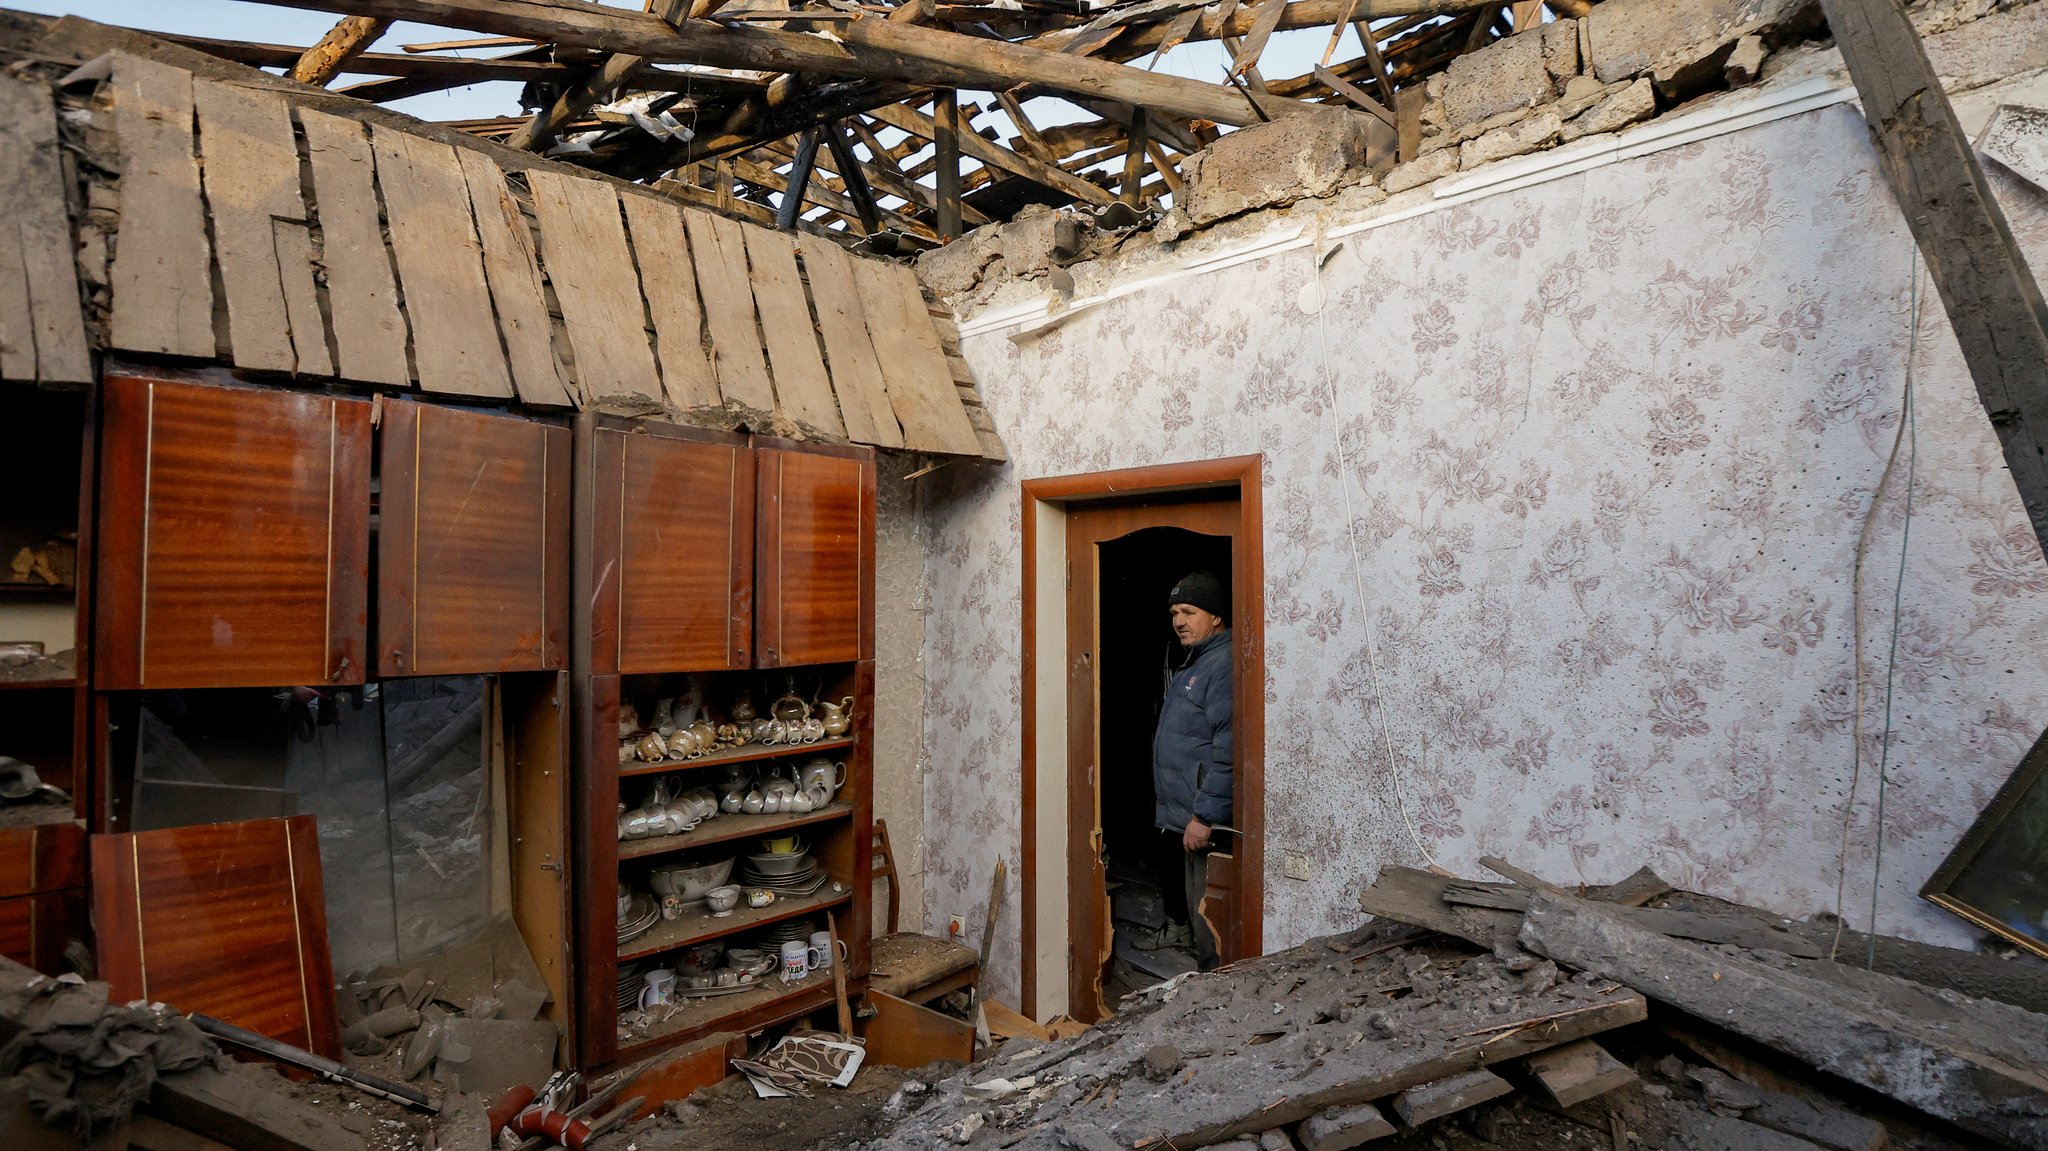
[1153,629,1233,834]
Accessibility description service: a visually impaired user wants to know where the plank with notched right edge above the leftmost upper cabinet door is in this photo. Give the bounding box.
[193,80,305,373]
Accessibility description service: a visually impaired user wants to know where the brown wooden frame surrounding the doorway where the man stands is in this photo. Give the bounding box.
[1018,455,1266,1014]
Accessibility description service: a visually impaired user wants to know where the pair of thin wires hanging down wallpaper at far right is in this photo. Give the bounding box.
[1827,246,1919,963]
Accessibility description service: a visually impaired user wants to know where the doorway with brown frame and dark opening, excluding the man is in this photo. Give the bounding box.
[1020,455,1266,1022]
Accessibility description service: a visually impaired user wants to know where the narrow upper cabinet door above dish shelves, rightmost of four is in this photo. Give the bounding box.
[754,446,874,668]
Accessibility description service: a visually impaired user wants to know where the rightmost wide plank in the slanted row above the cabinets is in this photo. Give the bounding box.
[854,260,981,455]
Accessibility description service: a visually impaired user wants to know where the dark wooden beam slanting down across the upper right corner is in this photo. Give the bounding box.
[1821,0,2048,549]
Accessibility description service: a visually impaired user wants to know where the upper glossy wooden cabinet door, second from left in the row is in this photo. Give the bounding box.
[377,399,569,676]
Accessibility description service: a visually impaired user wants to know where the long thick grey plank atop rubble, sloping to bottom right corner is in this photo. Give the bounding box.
[1522,893,2048,1147]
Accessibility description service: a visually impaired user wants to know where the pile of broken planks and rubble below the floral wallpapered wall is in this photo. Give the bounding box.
[831,862,2048,1151]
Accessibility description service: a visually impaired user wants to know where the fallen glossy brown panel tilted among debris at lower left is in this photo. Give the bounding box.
[92,815,340,1059]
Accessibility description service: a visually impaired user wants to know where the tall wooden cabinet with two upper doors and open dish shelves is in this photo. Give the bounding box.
[571,416,874,1069]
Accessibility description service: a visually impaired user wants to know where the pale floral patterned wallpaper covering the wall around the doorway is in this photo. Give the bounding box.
[926,106,2048,1001]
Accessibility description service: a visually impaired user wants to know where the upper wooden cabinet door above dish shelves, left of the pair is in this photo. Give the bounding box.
[590,426,754,676]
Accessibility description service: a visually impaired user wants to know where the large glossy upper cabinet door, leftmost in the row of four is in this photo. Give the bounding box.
[96,375,371,688]
